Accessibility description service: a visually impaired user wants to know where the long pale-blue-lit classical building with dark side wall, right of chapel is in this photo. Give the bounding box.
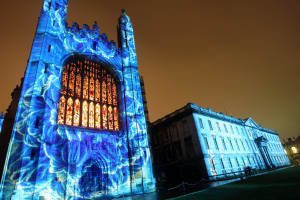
[151,103,290,185]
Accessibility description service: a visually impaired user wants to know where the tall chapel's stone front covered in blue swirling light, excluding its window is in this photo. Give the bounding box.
[0,0,155,199]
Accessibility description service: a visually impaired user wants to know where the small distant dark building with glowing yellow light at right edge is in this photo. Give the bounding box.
[283,135,300,164]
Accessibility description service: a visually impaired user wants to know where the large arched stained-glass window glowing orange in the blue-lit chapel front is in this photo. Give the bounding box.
[57,59,119,130]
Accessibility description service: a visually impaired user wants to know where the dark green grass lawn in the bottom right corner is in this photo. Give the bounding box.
[172,165,300,200]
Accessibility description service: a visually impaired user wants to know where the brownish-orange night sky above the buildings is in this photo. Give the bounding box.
[0,0,300,141]
